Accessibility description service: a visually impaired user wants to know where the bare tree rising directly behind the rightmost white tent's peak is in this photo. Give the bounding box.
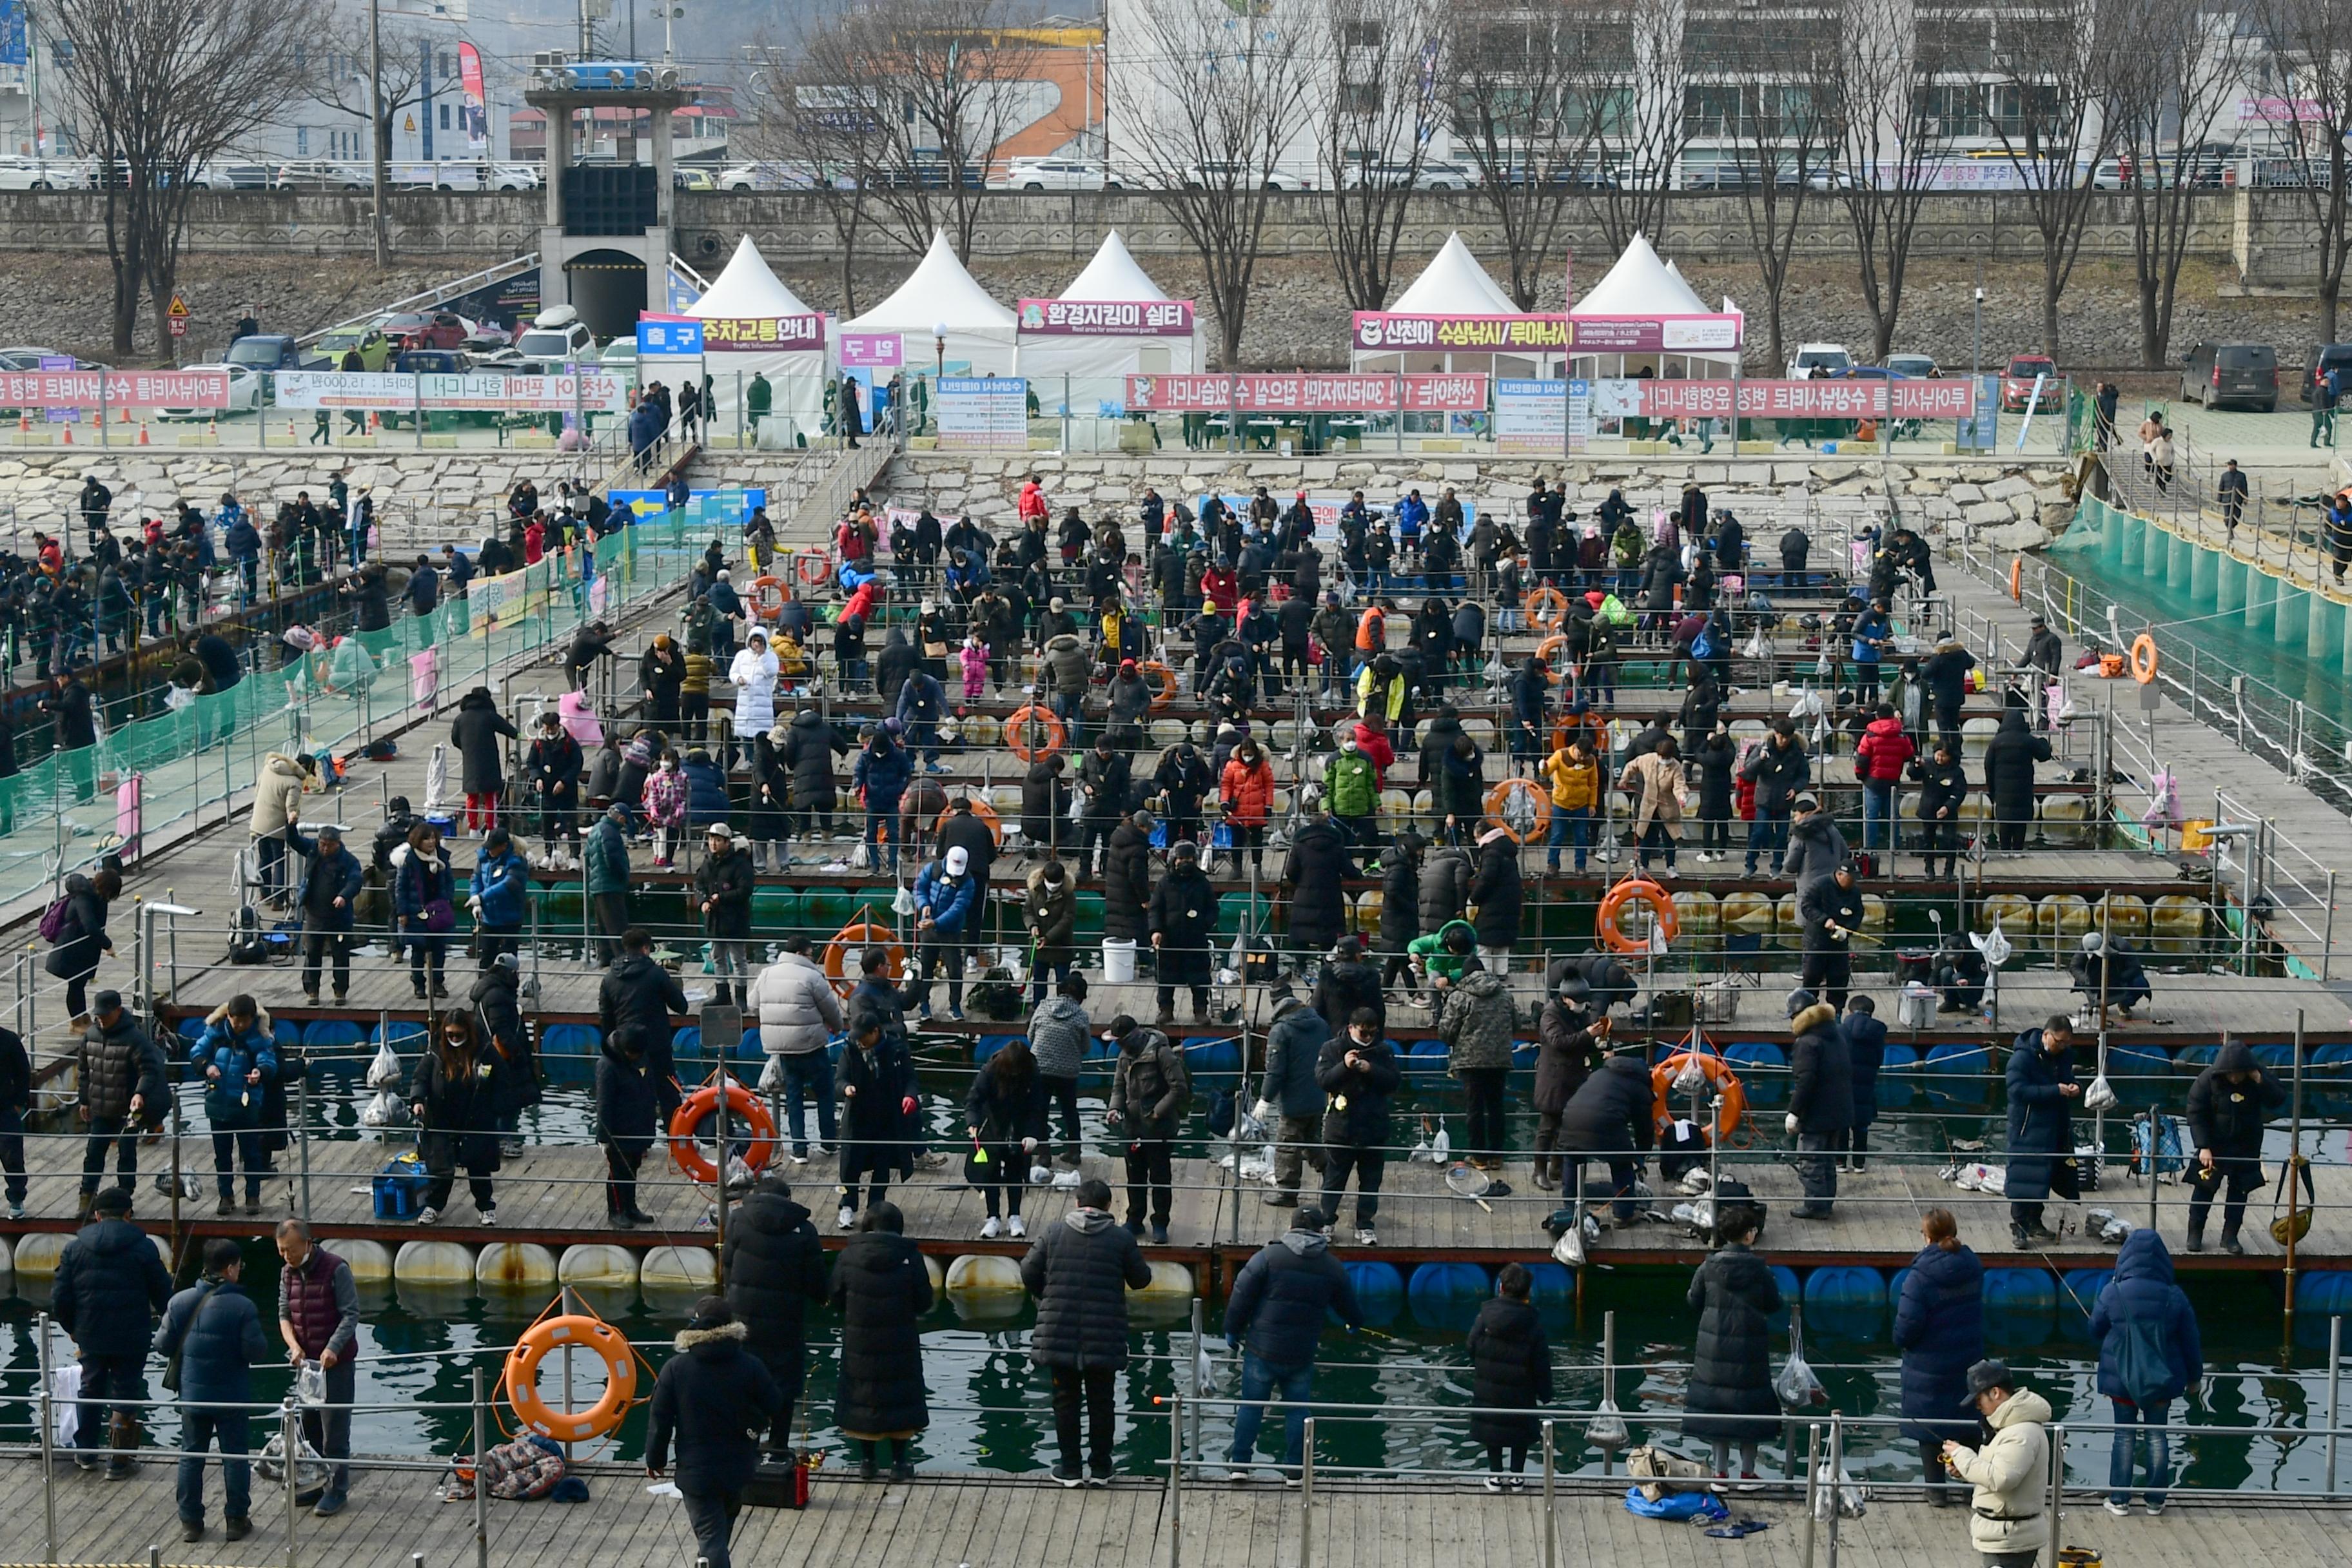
[1567,0,1693,251]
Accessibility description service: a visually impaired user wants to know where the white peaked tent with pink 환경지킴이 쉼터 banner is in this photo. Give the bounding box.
[1019,230,1204,392]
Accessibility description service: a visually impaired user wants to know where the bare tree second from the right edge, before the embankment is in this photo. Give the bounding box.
[2112,0,2239,369]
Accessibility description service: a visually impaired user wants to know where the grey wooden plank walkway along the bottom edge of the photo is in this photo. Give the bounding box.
[0,1460,2352,1568]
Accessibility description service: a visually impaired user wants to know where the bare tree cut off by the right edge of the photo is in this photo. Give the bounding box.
[2260,0,2352,343]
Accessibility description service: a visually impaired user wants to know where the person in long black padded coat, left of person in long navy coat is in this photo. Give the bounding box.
[1681,1201,1781,1481]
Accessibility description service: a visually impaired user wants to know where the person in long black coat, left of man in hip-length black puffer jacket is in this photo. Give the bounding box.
[832,1201,932,1481]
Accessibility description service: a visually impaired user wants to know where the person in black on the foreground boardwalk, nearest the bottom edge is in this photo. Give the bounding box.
[645,1297,781,1568]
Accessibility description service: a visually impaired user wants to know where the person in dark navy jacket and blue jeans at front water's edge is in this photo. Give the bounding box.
[1226,1204,1364,1476]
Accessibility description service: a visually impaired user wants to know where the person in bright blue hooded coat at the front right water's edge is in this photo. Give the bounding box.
[2091,1230,2204,1518]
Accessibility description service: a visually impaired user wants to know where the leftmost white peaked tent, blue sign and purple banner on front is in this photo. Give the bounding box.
[672,235,832,447]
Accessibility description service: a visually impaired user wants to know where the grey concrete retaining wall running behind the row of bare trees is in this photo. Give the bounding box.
[0,190,2309,277]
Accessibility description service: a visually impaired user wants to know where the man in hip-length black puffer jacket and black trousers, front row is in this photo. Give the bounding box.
[1021,1178,1153,1485]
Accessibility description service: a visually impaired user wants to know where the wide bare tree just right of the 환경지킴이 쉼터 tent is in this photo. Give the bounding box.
[1110,0,1320,369]
